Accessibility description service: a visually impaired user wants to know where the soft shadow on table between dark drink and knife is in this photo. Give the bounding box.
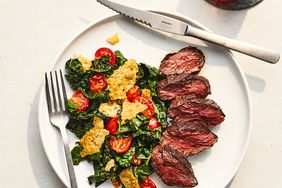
[176,0,249,38]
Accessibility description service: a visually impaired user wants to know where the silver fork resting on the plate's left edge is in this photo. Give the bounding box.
[45,70,77,188]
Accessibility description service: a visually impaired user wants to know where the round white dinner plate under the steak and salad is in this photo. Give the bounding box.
[38,11,251,188]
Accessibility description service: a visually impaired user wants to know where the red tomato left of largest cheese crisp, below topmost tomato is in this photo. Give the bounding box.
[89,74,108,93]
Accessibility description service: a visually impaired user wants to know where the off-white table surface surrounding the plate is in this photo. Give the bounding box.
[0,0,282,188]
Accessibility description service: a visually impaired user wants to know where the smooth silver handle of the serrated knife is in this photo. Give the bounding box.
[185,26,280,64]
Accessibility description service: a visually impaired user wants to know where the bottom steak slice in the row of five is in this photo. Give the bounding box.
[151,145,198,188]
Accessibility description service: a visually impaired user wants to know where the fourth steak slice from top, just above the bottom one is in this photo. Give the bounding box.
[161,121,217,156]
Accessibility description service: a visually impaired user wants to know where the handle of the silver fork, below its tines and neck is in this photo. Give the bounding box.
[60,128,77,188]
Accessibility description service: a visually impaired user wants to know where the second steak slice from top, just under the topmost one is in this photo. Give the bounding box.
[157,75,211,100]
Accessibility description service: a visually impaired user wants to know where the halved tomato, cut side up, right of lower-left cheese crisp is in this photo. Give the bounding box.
[110,136,132,154]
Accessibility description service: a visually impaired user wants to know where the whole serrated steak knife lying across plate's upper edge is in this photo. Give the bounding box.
[97,0,280,64]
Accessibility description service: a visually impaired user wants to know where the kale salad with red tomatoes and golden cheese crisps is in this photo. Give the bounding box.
[65,48,168,187]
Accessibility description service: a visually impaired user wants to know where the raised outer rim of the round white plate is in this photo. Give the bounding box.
[37,9,253,187]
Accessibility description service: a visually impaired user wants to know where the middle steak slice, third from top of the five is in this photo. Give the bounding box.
[168,95,225,127]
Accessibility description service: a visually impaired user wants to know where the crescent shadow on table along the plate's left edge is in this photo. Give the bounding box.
[27,87,64,188]
